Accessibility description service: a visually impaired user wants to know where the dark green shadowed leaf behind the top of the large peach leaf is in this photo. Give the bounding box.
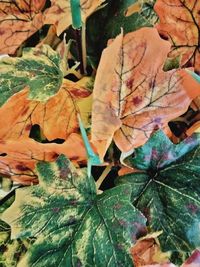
[87,0,157,67]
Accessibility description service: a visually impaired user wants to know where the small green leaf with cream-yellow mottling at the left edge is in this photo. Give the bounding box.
[0,45,63,106]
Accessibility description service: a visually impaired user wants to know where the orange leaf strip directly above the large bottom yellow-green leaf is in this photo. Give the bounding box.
[0,133,86,185]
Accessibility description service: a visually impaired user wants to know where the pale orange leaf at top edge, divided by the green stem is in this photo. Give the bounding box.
[44,0,105,35]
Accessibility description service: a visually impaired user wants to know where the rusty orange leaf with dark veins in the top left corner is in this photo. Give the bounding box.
[0,0,46,54]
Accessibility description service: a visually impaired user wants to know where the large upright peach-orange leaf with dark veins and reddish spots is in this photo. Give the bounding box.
[92,28,200,160]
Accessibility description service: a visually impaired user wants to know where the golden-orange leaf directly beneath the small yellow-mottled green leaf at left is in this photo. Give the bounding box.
[0,80,90,140]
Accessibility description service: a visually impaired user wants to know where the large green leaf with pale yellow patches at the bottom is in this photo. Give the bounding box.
[2,155,145,267]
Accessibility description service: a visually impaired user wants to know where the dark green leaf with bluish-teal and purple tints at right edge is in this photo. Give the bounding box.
[118,131,200,255]
